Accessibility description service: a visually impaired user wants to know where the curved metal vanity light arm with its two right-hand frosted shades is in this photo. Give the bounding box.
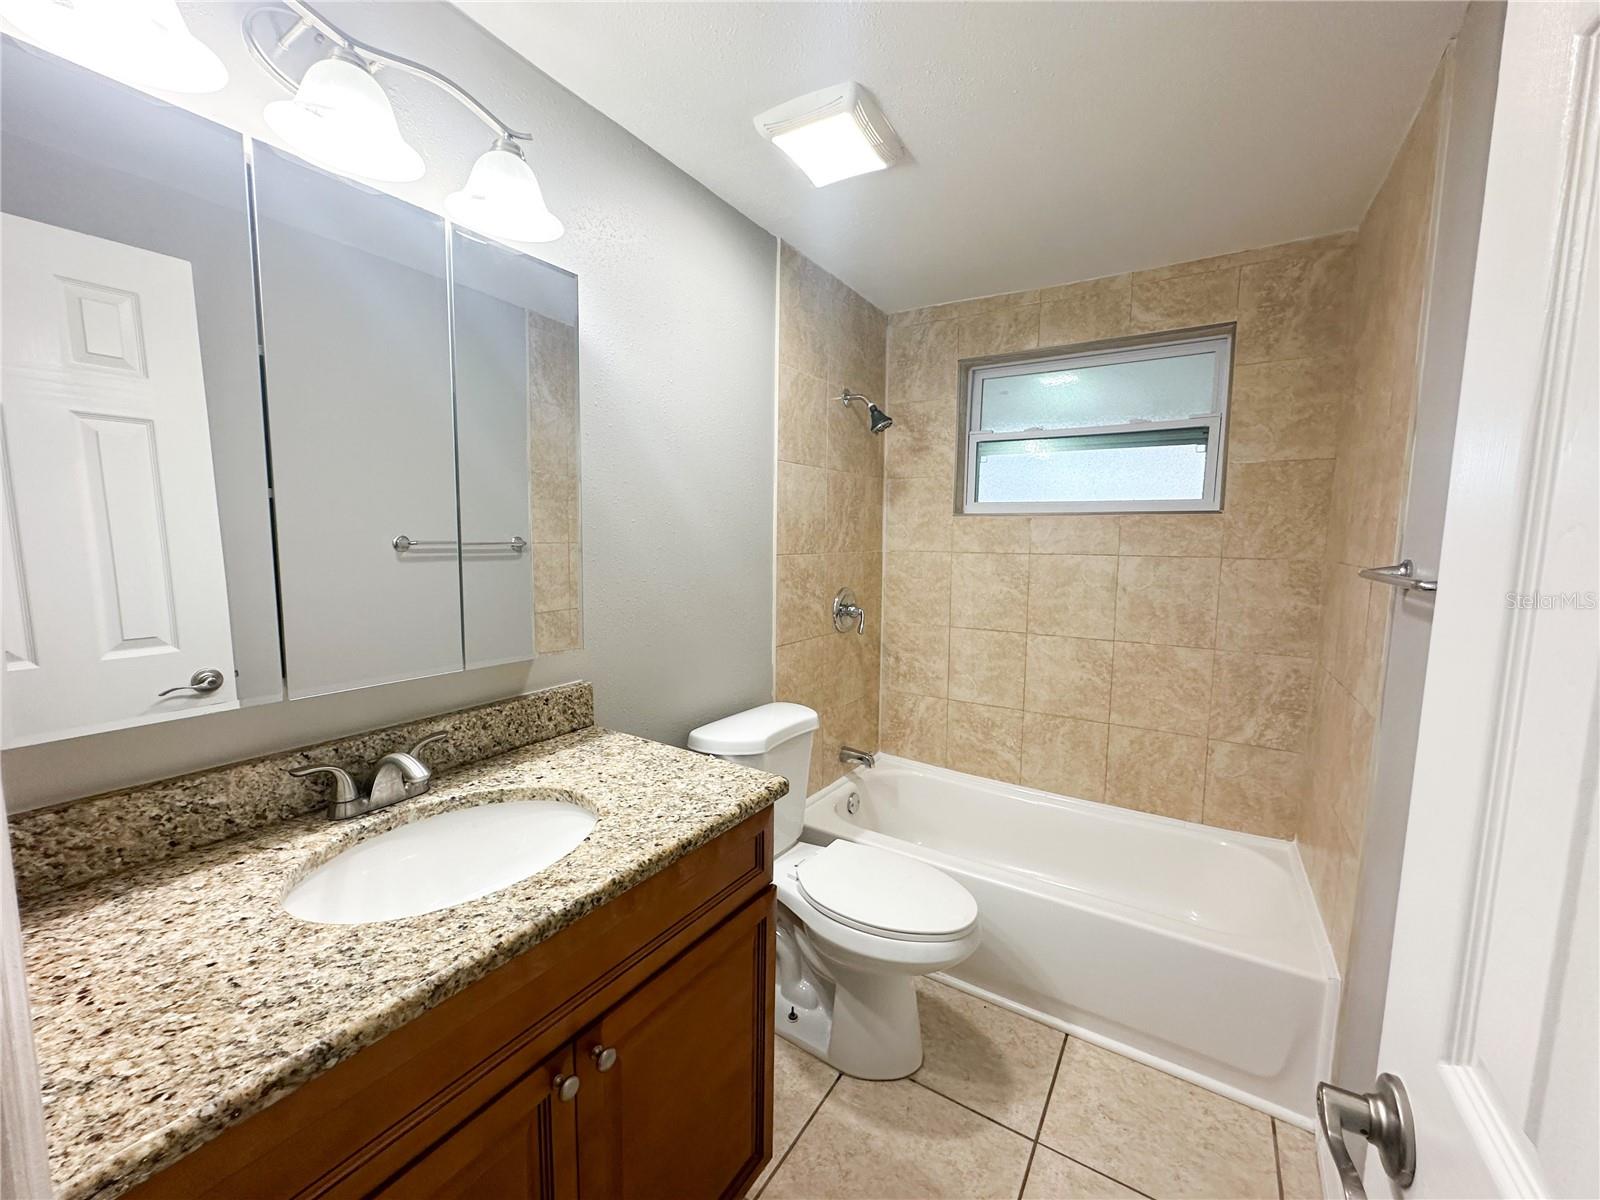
[236,0,563,242]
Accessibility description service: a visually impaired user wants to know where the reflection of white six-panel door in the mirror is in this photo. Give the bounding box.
[0,214,238,746]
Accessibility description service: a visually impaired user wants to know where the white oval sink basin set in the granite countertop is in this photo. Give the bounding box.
[283,800,595,925]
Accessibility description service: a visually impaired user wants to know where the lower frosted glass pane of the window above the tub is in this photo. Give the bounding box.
[976,429,1210,504]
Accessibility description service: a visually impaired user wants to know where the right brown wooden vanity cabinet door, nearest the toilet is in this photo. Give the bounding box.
[578,890,773,1200]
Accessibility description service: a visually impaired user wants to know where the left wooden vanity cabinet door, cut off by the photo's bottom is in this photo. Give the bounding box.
[373,1045,578,1200]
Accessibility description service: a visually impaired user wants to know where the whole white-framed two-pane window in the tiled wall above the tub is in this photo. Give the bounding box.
[963,331,1234,512]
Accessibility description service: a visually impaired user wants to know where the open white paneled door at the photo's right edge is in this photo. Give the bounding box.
[1328,3,1600,1198]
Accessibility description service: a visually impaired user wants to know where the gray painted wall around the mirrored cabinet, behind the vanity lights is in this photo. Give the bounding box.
[3,2,776,808]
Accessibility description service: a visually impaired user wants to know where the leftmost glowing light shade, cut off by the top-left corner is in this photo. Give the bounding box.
[0,0,227,93]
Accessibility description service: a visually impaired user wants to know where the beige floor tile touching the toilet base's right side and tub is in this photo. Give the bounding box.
[912,979,1064,1138]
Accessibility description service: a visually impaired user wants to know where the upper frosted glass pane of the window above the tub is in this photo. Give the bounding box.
[978,350,1218,434]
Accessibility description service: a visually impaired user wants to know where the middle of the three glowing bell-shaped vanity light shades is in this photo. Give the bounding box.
[262,56,426,182]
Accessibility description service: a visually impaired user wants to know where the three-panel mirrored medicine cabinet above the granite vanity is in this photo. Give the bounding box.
[0,38,582,747]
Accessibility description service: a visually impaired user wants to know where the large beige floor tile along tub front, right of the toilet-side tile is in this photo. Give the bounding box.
[1040,1037,1278,1200]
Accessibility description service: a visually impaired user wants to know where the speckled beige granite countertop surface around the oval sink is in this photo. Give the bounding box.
[22,728,787,1200]
